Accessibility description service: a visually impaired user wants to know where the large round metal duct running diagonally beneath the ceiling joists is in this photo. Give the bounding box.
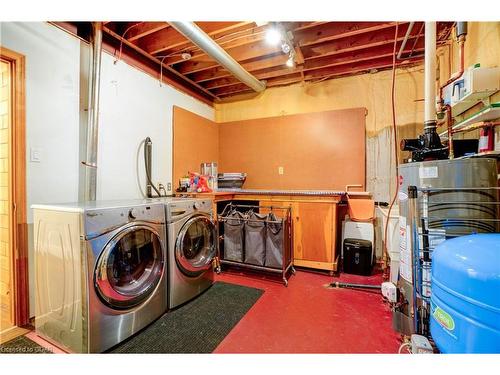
[169,21,266,92]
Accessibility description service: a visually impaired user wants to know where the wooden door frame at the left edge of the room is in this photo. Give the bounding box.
[0,45,29,327]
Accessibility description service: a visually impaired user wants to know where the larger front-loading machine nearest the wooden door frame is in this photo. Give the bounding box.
[33,200,168,353]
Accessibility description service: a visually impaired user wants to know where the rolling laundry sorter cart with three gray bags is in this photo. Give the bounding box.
[217,203,295,286]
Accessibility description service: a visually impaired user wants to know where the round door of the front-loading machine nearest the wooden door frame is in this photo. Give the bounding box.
[95,225,164,309]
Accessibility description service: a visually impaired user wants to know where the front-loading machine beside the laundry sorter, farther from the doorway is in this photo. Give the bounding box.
[165,198,217,309]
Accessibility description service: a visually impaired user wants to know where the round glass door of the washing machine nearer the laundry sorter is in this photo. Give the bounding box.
[175,216,216,277]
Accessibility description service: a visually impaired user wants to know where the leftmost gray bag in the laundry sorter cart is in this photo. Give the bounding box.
[224,210,245,262]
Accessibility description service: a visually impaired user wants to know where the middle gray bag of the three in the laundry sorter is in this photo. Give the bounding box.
[245,211,267,266]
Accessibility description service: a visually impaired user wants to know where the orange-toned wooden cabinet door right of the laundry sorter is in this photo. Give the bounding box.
[292,202,335,268]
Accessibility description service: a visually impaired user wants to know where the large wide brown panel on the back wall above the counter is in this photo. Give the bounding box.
[219,108,366,190]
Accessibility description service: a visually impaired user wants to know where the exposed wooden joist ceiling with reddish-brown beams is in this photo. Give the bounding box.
[103,22,453,101]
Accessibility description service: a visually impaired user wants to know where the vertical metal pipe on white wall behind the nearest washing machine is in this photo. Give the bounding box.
[82,22,102,201]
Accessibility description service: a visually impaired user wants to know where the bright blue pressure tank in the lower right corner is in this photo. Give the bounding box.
[431,233,500,353]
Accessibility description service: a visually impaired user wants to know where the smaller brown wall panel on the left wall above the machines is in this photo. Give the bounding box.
[172,106,219,190]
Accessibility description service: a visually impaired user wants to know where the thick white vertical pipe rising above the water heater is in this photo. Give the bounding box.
[424,22,437,127]
